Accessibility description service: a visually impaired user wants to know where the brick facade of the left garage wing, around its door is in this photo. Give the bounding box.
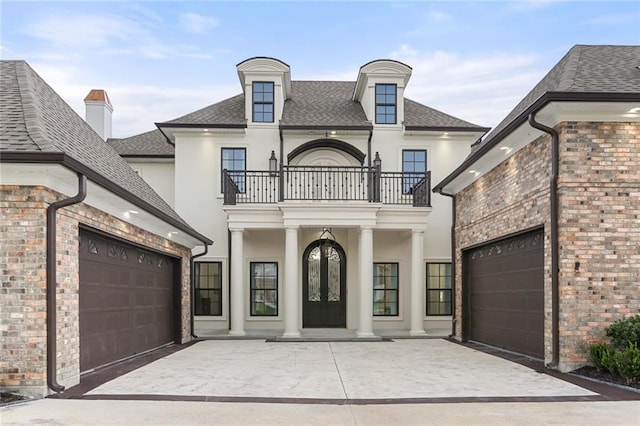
[0,186,191,396]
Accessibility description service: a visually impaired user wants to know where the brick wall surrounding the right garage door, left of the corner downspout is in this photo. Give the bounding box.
[455,137,552,361]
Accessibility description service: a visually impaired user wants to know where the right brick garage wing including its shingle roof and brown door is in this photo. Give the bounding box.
[434,45,640,371]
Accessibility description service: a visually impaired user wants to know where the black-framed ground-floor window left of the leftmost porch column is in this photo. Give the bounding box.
[194,262,222,316]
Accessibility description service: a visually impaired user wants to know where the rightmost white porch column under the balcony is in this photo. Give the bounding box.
[409,229,426,336]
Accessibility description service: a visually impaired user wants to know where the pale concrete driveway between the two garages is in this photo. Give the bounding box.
[85,339,598,403]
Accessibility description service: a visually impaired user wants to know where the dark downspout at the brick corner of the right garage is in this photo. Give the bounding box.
[529,112,560,368]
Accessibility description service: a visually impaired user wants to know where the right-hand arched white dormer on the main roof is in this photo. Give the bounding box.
[353,59,411,128]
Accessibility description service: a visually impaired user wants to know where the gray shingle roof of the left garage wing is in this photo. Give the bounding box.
[0,60,211,244]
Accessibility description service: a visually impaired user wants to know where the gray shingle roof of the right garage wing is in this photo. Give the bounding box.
[481,45,640,150]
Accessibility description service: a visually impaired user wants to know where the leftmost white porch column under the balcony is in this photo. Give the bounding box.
[229,229,247,336]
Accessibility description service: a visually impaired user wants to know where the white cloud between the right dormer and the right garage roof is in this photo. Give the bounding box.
[391,45,548,127]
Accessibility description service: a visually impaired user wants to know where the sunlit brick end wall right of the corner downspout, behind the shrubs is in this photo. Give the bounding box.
[558,122,640,369]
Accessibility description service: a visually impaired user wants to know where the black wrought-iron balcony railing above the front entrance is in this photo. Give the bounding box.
[223,166,431,207]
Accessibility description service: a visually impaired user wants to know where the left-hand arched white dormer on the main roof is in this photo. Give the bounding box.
[236,57,291,125]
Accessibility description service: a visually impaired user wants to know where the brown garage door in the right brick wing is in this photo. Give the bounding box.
[463,229,544,358]
